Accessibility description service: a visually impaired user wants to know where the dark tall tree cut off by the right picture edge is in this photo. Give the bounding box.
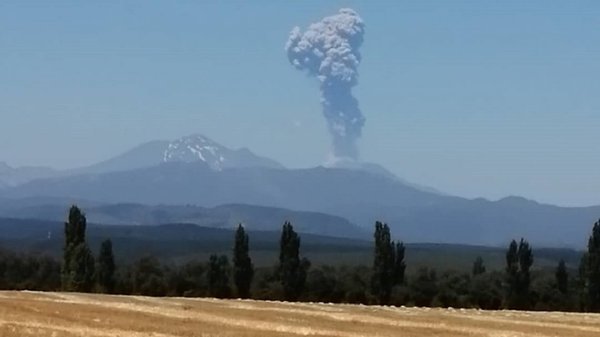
[580,220,600,312]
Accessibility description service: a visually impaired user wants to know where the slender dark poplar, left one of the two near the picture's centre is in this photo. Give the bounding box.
[233,224,254,298]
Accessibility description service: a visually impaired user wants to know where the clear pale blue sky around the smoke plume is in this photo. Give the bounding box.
[0,0,600,205]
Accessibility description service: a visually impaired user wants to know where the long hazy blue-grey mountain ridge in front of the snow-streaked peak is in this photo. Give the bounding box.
[0,162,600,247]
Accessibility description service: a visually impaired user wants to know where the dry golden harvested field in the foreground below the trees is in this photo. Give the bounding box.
[0,292,600,337]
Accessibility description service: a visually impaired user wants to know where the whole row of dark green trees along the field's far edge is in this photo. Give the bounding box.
[0,206,600,312]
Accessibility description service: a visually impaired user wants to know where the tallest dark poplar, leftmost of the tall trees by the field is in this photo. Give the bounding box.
[61,206,95,292]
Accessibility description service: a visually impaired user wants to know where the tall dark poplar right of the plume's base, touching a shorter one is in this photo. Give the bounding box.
[371,221,396,304]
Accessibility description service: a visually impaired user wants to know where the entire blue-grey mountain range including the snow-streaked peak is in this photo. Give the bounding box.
[0,135,600,247]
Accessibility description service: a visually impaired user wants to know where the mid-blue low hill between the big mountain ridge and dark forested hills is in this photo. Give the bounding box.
[0,199,369,239]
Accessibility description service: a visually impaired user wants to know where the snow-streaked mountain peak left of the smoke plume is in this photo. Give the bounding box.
[163,134,283,171]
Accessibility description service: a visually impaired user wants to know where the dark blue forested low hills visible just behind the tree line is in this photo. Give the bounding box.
[0,216,581,272]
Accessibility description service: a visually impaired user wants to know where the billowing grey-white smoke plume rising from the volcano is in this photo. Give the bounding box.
[285,8,365,159]
